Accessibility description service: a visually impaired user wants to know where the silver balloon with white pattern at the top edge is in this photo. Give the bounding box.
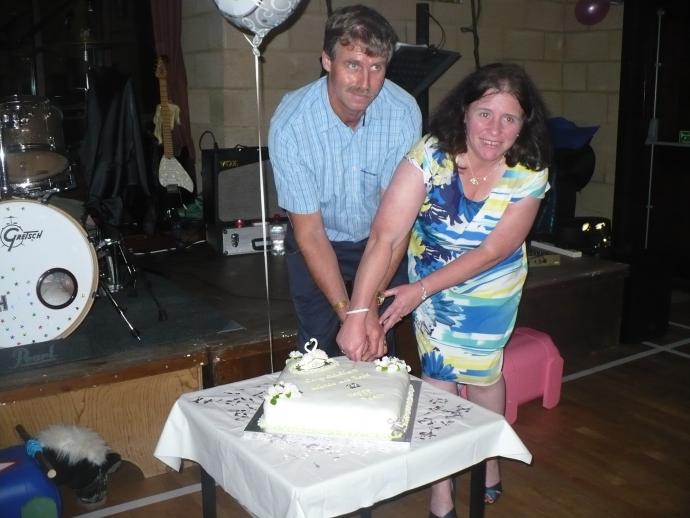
[214,0,302,46]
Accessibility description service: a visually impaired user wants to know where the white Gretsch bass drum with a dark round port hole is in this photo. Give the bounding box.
[0,200,98,348]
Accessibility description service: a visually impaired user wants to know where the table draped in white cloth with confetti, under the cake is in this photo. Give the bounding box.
[154,374,532,518]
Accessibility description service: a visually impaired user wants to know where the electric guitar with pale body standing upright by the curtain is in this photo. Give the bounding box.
[156,57,194,193]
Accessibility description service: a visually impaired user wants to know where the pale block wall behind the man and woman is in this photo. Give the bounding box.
[182,0,623,217]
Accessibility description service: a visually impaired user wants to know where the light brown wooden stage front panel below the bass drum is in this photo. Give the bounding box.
[0,365,201,477]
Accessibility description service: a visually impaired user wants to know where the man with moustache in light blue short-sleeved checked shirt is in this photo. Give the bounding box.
[268,5,421,360]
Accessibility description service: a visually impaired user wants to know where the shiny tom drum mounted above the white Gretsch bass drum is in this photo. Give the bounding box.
[0,95,73,194]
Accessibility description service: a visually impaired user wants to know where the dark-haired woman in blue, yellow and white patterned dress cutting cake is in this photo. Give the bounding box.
[337,63,551,518]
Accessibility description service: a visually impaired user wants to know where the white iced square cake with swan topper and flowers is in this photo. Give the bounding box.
[259,339,414,440]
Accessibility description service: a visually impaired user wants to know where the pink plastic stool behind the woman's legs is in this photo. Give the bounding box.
[503,327,563,424]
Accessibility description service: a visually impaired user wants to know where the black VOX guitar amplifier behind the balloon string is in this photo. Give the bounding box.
[201,146,281,227]
